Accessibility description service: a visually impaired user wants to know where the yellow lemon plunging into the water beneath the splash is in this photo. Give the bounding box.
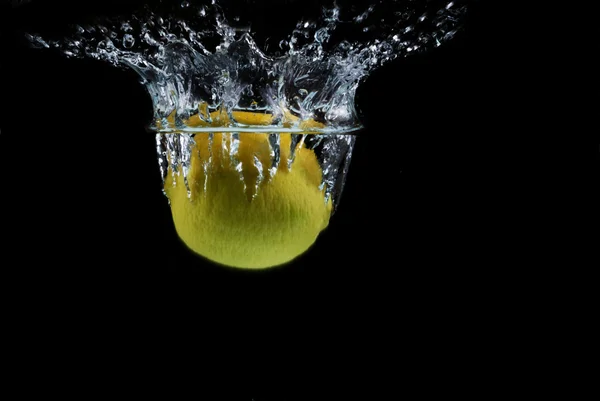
[165,112,332,269]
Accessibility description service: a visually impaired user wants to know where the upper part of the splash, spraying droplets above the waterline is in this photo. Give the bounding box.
[29,0,466,133]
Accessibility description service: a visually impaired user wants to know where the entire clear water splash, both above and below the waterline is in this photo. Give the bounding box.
[29,0,466,207]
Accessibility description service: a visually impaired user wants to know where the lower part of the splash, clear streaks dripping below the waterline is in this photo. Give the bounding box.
[156,132,356,208]
